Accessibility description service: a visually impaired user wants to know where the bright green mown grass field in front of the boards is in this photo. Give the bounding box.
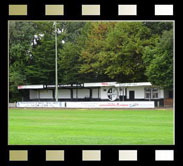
[9,109,174,145]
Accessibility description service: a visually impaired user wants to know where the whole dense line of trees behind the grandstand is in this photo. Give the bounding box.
[9,21,173,102]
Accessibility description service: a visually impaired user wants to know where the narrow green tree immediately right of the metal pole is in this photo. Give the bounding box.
[58,22,86,84]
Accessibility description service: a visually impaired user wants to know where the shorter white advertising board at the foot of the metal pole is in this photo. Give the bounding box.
[17,102,65,108]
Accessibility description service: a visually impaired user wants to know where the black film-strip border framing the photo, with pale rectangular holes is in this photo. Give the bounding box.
[0,0,180,166]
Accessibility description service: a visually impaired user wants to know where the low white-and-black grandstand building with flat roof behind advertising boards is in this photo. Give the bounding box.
[18,82,172,106]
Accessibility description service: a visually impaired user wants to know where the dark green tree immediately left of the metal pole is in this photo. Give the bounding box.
[26,22,66,84]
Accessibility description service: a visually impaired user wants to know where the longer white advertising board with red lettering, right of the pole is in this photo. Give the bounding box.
[66,101,154,108]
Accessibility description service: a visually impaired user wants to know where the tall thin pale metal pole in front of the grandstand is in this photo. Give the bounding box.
[54,21,58,102]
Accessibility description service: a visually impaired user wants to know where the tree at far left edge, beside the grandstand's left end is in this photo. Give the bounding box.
[9,21,35,102]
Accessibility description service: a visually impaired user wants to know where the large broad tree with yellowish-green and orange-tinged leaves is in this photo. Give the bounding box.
[80,22,157,82]
